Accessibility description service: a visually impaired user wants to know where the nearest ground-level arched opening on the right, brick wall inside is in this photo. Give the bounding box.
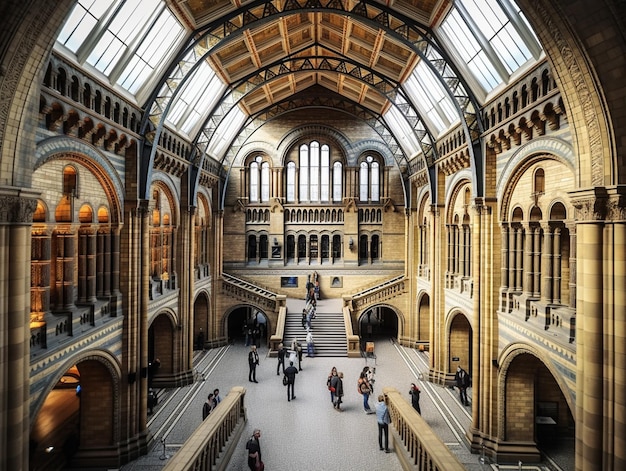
[504,353,575,454]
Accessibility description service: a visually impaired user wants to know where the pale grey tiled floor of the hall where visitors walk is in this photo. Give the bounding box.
[121,302,571,471]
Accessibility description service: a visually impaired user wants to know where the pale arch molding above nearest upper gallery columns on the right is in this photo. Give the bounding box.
[496,138,576,221]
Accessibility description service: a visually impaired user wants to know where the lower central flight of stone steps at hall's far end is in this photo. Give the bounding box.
[283,302,348,357]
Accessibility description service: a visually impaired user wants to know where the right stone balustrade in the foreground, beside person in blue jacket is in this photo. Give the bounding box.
[383,388,465,471]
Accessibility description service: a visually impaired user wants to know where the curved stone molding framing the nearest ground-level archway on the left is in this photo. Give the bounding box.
[30,350,122,436]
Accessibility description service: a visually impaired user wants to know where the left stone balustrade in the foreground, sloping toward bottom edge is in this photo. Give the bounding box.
[163,386,247,471]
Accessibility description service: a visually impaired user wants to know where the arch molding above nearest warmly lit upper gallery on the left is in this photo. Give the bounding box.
[33,136,124,223]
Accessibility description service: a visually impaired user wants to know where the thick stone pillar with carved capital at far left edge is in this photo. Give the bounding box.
[0,192,37,470]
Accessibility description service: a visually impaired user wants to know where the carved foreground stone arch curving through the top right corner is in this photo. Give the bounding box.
[517,0,626,188]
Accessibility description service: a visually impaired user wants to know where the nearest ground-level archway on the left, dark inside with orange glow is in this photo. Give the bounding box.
[29,358,119,471]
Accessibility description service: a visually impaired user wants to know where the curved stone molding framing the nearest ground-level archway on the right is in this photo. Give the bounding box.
[497,342,576,440]
